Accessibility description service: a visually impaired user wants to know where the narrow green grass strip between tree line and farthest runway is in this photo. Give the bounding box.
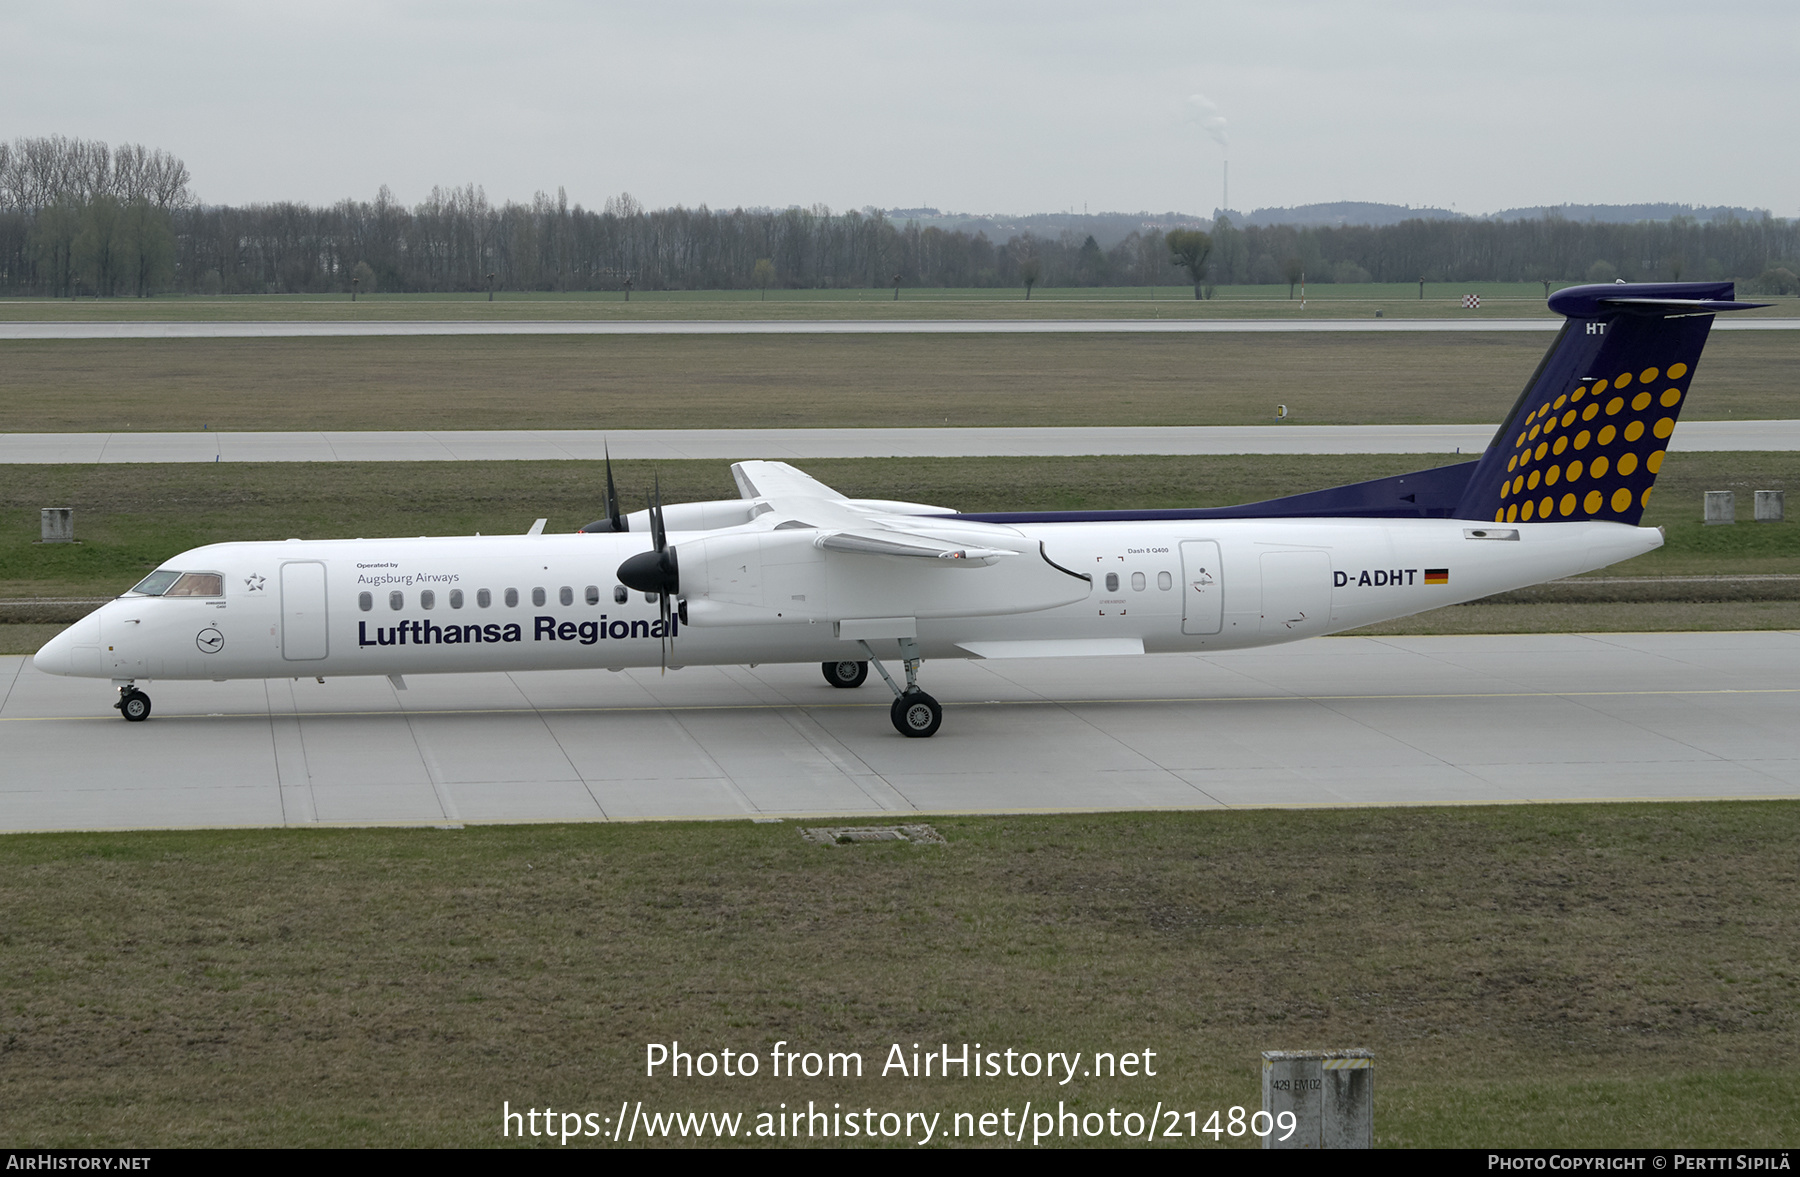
[0,283,1800,322]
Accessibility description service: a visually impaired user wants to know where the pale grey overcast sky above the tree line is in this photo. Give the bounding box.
[0,0,1800,216]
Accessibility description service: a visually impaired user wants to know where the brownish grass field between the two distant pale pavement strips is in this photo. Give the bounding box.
[0,331,1800,432]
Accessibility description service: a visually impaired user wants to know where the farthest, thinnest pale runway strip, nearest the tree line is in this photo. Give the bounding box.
[0,319,1800,340]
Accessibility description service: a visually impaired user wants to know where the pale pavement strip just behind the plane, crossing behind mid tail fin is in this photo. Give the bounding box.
[0,421,1800,464]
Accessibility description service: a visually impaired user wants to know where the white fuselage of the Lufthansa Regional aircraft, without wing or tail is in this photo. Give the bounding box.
[36,518,1661,680]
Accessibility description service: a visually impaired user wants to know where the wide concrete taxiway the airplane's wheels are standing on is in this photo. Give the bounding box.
[0,632,1800,831]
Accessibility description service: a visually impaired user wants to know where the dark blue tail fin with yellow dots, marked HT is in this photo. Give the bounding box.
[1454,283,1762,526]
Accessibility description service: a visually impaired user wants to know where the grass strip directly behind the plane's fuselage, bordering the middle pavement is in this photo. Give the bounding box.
[0,454,1800,597]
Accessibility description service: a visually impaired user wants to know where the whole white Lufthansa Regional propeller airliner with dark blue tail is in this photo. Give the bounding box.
[36,283,1755,736]
